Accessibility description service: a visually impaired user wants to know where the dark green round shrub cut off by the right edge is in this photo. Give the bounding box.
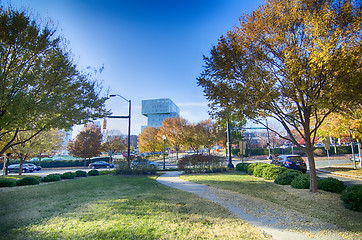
[341,185,362,212]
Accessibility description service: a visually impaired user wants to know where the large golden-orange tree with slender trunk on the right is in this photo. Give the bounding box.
[198,0,362,192]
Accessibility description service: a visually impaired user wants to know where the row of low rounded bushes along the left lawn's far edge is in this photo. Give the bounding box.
[0,169,111,187]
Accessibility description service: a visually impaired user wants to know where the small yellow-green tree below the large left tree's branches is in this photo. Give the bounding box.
[5,129,62,175]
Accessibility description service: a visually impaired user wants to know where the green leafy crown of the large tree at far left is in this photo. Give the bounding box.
[0,6,109,158]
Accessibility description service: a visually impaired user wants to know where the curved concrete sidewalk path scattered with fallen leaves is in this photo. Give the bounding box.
[156,172,344,240]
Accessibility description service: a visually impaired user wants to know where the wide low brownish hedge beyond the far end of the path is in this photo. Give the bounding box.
[177,154,226,170]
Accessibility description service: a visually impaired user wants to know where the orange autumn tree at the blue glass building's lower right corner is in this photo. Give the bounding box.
[158,117,188,160]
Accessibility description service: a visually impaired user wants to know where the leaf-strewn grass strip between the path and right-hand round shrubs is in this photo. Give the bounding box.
[181,172,362,234]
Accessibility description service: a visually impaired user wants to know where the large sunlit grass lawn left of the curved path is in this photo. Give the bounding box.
[0,175,265,239]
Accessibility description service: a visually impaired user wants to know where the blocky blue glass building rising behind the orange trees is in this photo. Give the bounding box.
[142,98,180,131]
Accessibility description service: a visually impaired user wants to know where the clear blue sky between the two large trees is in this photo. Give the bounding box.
[12,0,264,134]
